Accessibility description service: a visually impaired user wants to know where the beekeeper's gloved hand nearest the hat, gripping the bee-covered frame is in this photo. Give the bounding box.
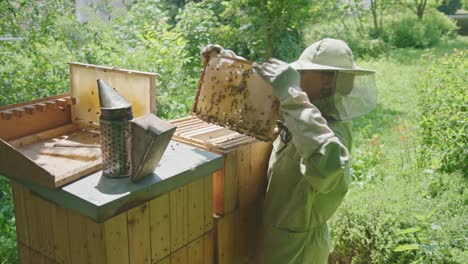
[253,59,300,100]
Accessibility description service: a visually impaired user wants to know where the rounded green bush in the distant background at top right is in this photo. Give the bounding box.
[387,11,457,48]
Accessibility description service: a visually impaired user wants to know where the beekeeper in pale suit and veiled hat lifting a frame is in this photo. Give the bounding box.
[203,38,377,264]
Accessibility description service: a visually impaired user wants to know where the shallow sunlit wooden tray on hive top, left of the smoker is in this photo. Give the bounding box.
[0,124,102,188]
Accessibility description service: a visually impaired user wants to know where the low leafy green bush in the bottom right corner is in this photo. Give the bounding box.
[329,170,468,264]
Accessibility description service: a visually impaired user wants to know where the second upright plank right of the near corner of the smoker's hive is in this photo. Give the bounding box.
[127,202,151,264]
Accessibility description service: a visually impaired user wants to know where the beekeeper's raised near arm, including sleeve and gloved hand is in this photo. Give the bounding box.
[254,59,349,192]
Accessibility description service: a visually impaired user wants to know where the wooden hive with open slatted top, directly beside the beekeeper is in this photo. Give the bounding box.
[171,117,272,264]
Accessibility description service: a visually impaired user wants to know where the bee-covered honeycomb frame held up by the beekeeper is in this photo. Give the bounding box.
[192,55,279,141]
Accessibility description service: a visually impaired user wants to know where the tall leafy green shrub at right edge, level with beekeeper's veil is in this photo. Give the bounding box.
[418,50,468,176]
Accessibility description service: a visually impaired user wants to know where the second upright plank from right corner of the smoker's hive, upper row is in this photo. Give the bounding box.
[187,176,206,242]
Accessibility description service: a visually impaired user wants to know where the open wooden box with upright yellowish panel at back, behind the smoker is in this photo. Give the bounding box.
[0,63,156,188]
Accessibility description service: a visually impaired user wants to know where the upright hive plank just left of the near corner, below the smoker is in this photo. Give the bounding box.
[86,218,108,264]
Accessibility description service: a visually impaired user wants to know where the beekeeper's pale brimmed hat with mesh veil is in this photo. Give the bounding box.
[290,38,377,120]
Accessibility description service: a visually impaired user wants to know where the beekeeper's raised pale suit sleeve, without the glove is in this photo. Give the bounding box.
[279,87,349,193]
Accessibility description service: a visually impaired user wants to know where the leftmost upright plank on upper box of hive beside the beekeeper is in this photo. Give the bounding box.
[222,150,239,214]
